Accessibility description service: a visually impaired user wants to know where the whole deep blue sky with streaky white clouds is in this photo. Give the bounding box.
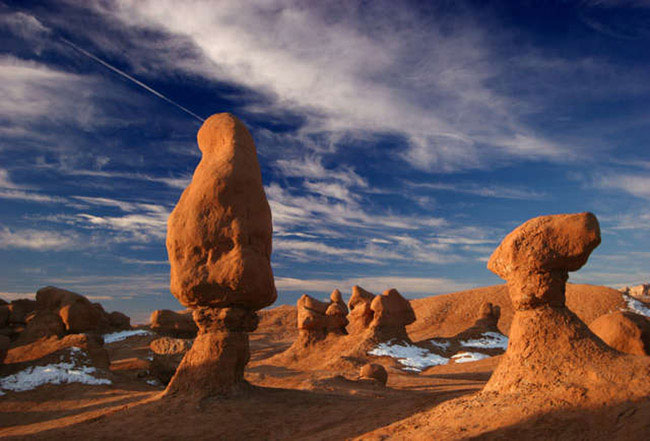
[0,0,650,321]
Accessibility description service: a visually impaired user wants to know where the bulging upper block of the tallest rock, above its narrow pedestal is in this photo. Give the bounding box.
[167,113,277,310]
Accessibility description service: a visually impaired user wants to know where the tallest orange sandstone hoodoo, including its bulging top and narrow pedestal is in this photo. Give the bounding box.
[167,113,277,398]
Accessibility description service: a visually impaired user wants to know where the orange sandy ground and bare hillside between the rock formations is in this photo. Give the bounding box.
[0,285,650,440]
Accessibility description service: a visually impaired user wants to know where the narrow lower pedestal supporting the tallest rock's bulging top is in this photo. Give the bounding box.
[166,307,258,398]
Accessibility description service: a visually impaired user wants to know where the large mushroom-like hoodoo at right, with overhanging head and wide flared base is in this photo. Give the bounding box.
[483,213,650,403]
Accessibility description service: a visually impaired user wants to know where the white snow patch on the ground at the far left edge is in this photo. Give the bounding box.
[0,347,111,392]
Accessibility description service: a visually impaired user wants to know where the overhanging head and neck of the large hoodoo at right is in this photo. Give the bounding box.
[488,213,600,310]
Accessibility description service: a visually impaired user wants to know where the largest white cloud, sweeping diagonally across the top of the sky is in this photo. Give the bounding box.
[85,0,572,171]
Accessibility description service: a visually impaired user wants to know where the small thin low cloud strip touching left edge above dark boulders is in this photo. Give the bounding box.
[0,228,78,251]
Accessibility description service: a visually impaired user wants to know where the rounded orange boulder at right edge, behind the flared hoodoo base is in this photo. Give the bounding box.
[589,311,650,355]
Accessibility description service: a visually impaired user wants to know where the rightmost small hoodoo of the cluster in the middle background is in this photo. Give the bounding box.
[370,289,415,340]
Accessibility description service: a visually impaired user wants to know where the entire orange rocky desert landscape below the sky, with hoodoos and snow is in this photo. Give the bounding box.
[0,114,650,440]
